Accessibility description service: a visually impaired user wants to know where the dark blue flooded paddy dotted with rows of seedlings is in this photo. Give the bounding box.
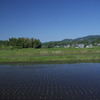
[0,63,100,100]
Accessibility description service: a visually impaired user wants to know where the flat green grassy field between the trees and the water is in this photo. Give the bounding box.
[0,47,100,63]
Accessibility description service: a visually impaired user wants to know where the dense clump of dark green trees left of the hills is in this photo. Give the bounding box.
[0,37,42,48]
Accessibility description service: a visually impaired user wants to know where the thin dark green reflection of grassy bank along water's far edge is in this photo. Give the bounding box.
[0,59,100,66]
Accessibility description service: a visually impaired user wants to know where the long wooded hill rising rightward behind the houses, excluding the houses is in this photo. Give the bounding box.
[43,35,100,47]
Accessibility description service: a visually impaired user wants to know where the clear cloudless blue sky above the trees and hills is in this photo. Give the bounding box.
[0,0,100,42]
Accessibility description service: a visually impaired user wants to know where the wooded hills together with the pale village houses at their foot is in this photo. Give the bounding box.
[42,35,100,48]
